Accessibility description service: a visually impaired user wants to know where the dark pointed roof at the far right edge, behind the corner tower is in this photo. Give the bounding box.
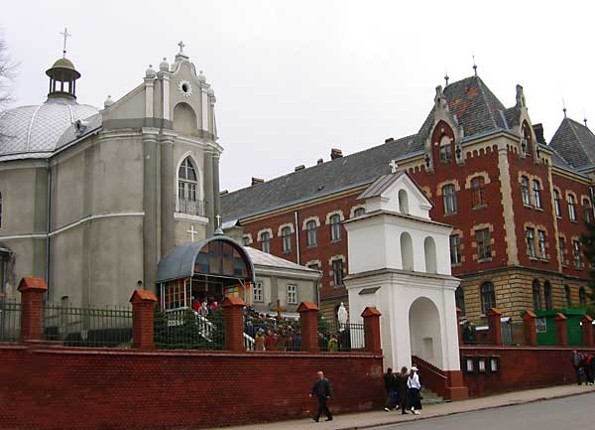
[549,118,595,168]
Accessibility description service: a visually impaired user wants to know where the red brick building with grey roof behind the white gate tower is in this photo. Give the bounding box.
[221,76,595,321]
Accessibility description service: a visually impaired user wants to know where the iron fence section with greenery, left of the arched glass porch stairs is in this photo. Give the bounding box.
[155,308,225,350]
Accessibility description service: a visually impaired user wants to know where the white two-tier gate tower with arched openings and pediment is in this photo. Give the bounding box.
[345,172,470,398]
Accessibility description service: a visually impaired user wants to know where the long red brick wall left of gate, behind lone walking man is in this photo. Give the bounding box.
[0,344,384,430]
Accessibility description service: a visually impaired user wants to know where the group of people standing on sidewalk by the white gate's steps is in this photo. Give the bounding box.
[384,366,422,415]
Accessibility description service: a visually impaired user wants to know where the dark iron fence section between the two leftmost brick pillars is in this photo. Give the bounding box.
[43,304,132,347]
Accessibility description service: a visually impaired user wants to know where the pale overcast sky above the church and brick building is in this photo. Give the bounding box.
[0,0,595,191]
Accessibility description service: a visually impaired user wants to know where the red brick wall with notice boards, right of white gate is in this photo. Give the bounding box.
[460,346,595,397]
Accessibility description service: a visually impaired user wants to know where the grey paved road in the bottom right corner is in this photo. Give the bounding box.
[374,393,595,430]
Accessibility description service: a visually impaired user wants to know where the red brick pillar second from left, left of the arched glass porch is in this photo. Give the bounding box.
[130,290,157,349]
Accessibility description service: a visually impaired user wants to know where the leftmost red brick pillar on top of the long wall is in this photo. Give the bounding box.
[18,277,48,341]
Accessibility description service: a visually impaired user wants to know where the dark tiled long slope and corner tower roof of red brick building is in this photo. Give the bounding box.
[221,76,519,221]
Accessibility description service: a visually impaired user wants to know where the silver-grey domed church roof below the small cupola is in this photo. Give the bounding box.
[0,98,99,159]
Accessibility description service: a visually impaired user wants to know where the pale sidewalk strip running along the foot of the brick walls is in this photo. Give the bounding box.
[217,384,595,430]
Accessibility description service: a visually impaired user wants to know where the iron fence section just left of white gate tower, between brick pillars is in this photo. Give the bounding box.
[318,321,365,352]
